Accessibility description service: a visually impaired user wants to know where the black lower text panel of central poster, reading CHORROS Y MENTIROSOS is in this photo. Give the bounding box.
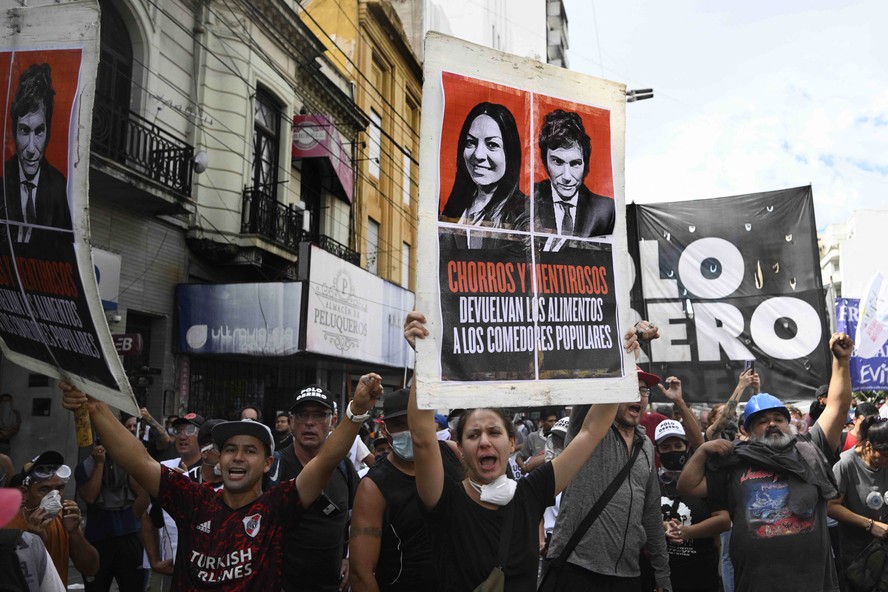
[439,229,621,381]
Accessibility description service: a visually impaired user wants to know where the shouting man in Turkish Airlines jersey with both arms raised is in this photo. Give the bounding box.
[59,373,382,592]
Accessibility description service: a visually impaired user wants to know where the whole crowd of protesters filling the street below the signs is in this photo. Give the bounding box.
[0,312,888,592]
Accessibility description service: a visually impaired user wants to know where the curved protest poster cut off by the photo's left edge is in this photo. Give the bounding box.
[0,2,138,414]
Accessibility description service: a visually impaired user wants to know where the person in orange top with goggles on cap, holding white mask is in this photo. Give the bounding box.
[7,450,99,585]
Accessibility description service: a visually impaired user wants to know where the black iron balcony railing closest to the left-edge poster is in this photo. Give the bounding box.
[91,97,194,197]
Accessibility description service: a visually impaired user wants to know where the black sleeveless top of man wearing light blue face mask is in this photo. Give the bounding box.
[367,442,463,592]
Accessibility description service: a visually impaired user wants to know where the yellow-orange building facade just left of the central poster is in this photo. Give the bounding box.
[303,0,422,289]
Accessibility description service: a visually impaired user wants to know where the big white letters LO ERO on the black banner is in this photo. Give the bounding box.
[638,237,824,362]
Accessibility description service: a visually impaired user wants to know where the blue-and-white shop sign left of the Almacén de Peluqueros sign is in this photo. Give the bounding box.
[176,282,302,356]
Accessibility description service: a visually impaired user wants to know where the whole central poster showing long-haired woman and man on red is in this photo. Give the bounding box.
[417,35,637,408]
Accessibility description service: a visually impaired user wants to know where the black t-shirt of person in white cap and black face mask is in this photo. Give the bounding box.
[660,478,719,590]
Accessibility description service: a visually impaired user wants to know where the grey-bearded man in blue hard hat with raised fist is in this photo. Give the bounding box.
[678,333,854,592]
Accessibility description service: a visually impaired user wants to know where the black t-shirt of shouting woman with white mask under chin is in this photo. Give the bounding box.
[427,463,555,592]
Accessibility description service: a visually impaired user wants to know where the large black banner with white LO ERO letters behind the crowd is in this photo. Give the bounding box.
[627,187,830,402]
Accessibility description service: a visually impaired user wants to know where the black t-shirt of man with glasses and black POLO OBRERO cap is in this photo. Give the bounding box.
[280,446,358,592]
